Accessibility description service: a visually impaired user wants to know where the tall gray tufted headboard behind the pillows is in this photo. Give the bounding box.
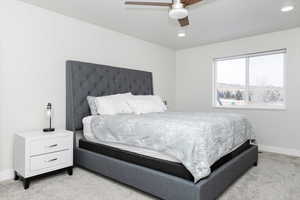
[66,61,153,131]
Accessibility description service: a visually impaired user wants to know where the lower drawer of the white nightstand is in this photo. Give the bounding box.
[30,150,72,171]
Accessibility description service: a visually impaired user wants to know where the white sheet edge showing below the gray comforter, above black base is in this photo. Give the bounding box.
[82,116,180,163]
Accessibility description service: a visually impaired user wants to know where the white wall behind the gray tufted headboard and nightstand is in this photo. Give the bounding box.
[0,0,175,175]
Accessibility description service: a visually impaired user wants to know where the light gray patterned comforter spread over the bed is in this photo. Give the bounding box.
[91,112,254,182]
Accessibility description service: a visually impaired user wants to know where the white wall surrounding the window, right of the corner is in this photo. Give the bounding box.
[176,28,300,156]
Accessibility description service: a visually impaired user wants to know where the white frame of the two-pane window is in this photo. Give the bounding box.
[212,49,287,110]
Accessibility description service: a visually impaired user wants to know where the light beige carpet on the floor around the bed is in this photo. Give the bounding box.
[0,153,300,200]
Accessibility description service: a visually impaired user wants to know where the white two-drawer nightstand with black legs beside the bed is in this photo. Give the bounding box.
[14,130,73,189]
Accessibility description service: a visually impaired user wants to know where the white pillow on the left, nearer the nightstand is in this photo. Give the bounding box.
[95,93,133,115]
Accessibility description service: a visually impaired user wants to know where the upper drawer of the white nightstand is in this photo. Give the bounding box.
[30,137,73,156]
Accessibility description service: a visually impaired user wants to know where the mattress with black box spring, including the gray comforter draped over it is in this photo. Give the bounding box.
[83,112,252,182]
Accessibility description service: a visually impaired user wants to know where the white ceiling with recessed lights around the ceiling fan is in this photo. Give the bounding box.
[23,0,300,49]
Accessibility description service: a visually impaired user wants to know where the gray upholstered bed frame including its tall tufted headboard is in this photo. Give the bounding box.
[66,61,258,200]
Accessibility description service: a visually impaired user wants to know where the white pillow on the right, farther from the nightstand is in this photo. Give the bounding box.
[127,95,167,115]
